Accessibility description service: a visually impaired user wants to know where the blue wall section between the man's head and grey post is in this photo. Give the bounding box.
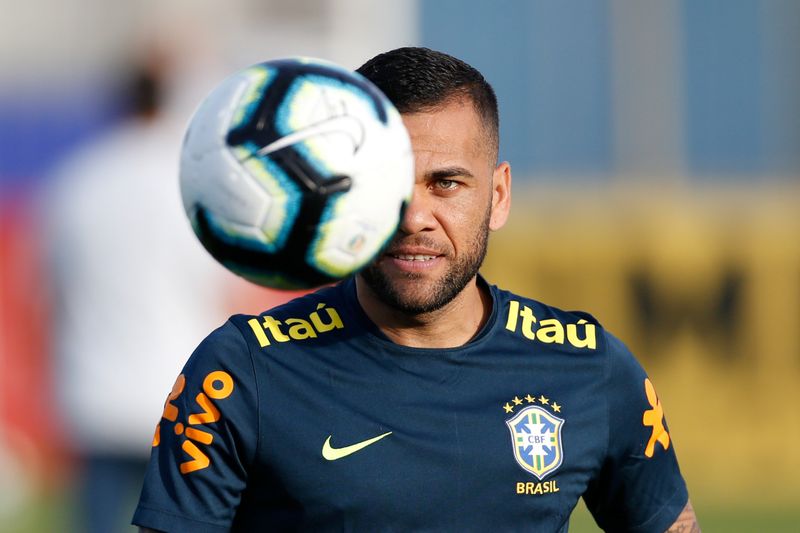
[420,0,613,177]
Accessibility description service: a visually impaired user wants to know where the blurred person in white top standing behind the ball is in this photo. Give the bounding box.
[44,51,232,533]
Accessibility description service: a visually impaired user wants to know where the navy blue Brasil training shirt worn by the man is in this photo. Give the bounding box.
[133,279,688,533]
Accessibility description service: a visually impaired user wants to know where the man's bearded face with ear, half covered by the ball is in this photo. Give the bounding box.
[362,99,510,314]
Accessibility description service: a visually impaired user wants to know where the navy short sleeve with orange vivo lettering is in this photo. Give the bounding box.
[133,322,258,533]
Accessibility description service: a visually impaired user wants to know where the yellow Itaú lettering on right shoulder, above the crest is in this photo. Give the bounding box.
[506,300,597,350]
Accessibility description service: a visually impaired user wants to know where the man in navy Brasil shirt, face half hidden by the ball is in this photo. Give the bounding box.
[134,48,697,532]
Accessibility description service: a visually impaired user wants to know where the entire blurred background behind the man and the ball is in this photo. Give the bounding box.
[0,0,800,533]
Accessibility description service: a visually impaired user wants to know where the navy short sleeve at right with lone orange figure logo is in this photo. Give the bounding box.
[584,335,688,533]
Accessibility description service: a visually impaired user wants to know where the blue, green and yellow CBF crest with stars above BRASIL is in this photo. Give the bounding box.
[506,395,564,480]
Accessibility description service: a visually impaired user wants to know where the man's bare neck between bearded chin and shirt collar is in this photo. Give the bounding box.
[356,276,492,348]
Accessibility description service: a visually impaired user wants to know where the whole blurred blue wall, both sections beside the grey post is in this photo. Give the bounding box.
[419,0,800,180]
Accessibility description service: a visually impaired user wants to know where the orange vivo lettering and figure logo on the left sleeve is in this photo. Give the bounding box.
[153,370,233,474]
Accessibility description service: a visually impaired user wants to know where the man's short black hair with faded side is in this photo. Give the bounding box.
[356,47,500,159]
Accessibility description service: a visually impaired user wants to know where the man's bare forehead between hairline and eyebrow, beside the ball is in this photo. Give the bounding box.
[403,98,489,163]
